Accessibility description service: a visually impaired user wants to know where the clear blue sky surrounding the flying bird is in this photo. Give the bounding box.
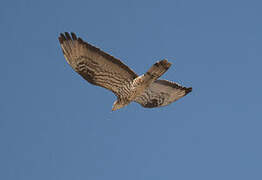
[0,0,262,180]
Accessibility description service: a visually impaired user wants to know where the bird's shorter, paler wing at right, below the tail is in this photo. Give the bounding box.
[135,80,192,108]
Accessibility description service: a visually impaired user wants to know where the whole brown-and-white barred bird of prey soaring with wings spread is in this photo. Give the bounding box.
[58,32,192,111]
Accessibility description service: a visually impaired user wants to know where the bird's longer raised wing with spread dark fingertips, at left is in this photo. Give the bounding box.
[59,32,137,96]
